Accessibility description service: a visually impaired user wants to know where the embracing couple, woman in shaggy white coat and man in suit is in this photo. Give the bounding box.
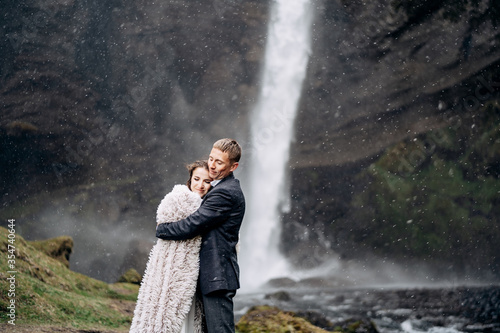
[130,139,245,333]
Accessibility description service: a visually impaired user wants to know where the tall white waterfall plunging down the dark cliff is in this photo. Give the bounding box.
[240,0,312,289]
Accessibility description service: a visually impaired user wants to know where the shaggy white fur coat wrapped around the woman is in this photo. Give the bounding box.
[130,185,202,333]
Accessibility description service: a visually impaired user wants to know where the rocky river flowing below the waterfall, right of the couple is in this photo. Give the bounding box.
[235,285,500,333]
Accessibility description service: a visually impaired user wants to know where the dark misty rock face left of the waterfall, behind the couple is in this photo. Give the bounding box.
[0,0,268,281]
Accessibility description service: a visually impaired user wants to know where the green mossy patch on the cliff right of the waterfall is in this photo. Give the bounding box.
[352,104,500,262]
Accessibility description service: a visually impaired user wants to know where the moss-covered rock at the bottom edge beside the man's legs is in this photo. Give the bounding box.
[236,305,328,333]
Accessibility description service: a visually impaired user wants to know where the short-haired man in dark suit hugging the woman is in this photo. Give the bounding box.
[156,139,245,333]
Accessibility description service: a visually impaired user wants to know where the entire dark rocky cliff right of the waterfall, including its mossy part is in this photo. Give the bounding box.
[283,1,500,278]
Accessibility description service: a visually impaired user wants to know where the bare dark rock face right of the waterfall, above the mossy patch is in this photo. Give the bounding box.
[291,0,500,167]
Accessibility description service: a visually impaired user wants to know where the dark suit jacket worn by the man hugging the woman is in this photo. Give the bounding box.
[156,173,245,294]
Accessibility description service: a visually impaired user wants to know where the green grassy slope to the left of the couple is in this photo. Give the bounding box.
[0,227,139,331]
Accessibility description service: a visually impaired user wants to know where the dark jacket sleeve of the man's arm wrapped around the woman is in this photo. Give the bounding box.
[156,188,233,240]
